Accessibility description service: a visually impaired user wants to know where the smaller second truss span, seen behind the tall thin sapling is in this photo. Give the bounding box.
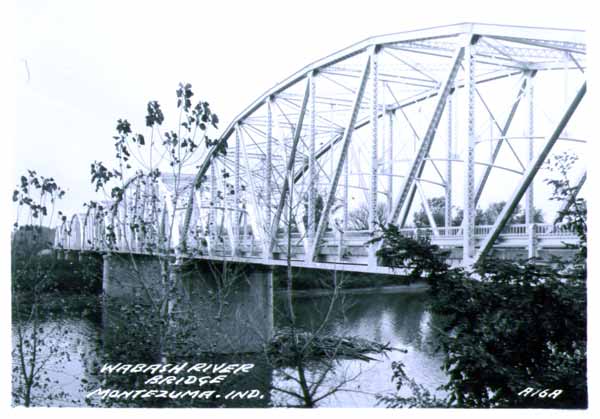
[100,173,237,254]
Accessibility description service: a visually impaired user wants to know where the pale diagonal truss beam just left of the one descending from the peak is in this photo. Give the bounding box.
[306,54,371,262]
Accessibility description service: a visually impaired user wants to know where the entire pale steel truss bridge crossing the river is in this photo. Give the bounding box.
[55,23,586,272]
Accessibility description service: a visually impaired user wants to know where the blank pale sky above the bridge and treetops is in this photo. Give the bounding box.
[11,0,586,220]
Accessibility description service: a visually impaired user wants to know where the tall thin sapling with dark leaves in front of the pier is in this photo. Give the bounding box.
[81,83,250,406]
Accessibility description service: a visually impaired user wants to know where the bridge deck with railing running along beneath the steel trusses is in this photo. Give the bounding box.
[58,225,577,274]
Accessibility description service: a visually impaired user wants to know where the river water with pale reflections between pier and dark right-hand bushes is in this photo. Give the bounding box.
[274,288,446,407]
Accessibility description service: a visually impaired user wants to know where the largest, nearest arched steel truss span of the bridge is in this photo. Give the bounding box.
[183,23,586,262]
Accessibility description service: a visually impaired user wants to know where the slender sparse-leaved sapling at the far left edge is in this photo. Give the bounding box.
[11,170,73,407]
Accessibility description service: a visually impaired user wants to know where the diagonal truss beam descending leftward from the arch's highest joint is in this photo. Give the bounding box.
[388,37,470,223]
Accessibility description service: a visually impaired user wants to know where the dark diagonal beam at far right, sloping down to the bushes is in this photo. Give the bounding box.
[473,82,587,263]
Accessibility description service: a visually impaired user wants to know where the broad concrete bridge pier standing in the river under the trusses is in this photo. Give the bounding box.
[102,253,273,354]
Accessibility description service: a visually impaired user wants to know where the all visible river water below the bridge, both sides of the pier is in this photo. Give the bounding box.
[13,276,446,407]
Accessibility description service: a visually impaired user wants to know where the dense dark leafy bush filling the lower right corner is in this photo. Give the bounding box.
[432,259,587,408]
